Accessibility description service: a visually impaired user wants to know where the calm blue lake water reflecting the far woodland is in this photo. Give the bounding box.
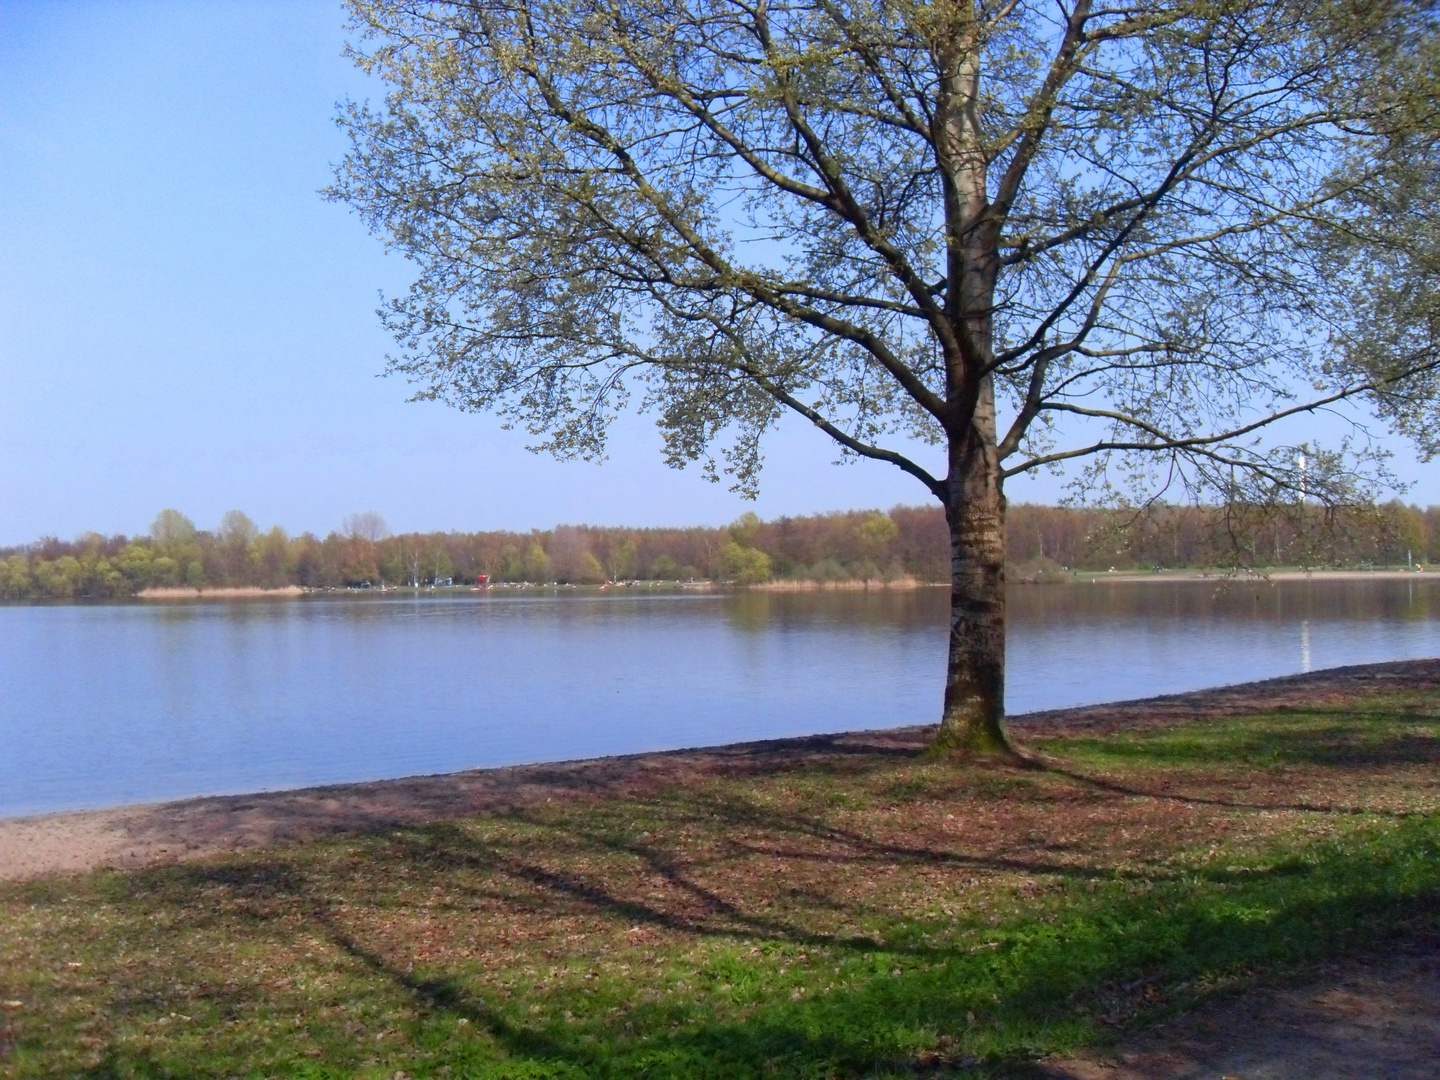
[0,579,1440,815]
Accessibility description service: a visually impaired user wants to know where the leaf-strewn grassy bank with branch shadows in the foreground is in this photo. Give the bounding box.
[0,691,1440,1080]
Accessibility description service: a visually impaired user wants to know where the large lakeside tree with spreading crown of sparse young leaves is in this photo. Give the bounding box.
[331,0,1440,752]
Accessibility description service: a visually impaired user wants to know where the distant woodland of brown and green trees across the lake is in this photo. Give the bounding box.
[0,503,1440,599]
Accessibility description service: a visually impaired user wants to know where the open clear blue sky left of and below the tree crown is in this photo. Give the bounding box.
[0,0,1436,544]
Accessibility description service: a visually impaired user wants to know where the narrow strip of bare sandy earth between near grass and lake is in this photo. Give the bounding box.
[0,658,1440,881]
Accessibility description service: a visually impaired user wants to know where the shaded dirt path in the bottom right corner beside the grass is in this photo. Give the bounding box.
[1024,942,1440,1080]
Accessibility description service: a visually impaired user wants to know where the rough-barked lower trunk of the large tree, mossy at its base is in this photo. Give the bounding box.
[935,380,1014,756]
